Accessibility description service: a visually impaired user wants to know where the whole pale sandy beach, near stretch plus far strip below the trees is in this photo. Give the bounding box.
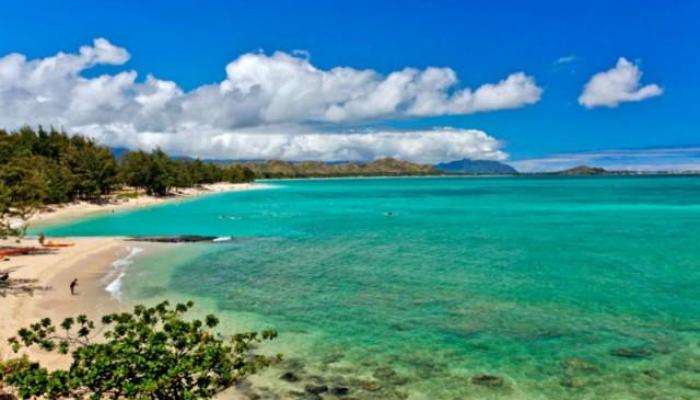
[0,183,263,367]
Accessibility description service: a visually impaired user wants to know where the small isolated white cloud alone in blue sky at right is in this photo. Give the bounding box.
[578,57,663,108]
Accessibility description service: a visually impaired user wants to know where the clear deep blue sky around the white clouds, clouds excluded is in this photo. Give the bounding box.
[0,0,700,170]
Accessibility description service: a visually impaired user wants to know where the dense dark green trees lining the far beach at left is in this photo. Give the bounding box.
[0,127,256,234]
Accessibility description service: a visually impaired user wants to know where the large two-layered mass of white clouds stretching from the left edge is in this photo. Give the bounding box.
[0,38,542,161]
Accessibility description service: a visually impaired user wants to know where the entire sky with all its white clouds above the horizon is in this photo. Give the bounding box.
[0,0,700,171]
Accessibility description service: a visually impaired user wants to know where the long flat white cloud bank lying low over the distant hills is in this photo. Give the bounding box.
[80,124,508,163]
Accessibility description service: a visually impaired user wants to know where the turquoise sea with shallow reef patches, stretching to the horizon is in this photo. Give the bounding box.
[39,177,700,399]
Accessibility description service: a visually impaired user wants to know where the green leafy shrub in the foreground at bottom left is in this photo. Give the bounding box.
[2,302,280,399]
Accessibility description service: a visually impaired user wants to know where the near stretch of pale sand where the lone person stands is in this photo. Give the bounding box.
[0,237,127,368]
